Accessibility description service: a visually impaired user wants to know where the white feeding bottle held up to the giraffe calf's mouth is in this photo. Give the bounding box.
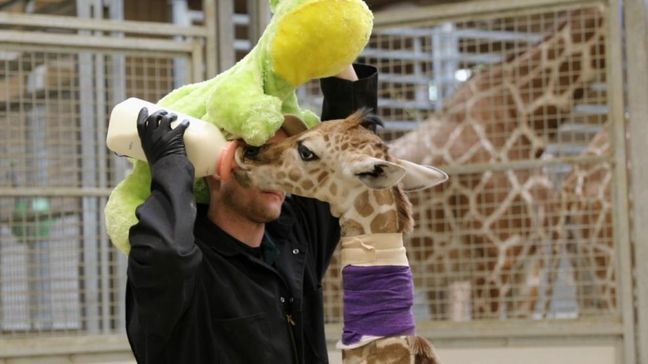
[106,97,235,177]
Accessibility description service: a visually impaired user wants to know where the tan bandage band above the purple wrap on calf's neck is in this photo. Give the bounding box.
[340,233,409,269]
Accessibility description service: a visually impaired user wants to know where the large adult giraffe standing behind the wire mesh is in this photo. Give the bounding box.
[384,7,606,319]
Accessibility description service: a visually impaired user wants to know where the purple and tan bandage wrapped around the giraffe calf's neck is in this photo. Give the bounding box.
[337,234,414,349]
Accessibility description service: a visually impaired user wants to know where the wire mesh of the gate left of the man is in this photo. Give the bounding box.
[0,45,190,338]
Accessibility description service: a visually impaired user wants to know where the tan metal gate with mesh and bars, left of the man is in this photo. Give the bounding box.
[0,0,270,362]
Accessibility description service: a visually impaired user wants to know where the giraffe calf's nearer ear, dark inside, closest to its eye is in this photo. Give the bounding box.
[349,157,405,189]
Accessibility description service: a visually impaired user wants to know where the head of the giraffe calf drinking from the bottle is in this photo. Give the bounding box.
[234,112,447,210]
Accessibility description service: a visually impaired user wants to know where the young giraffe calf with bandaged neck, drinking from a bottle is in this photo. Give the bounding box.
[234,112,448,363]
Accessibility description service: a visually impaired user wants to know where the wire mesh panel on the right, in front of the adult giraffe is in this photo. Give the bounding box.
[301,6,619,322]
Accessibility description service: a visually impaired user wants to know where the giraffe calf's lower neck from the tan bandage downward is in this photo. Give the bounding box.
[337,234,440,364]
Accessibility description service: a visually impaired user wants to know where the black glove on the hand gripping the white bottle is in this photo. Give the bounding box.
[137,107,189,165]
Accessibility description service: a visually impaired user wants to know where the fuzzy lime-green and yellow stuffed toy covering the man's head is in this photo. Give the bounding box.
[105,0,373,254]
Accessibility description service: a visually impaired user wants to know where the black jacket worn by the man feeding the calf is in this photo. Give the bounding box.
[126,65,377,364]
